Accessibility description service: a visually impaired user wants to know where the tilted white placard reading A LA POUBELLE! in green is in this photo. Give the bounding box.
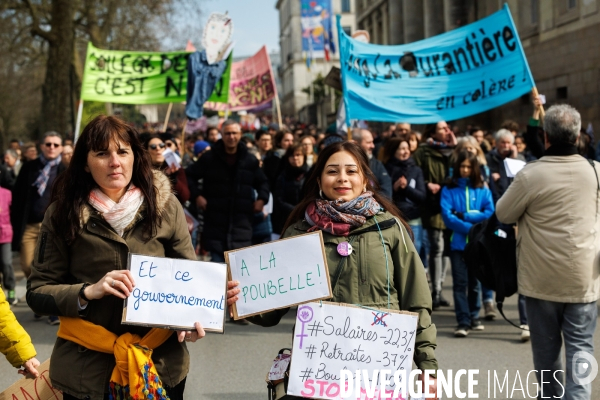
[225,231,331,319]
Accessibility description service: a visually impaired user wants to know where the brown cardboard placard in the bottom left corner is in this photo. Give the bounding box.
[0,359,63,400]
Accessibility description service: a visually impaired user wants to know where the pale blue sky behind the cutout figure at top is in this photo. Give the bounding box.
[191,0,279,57]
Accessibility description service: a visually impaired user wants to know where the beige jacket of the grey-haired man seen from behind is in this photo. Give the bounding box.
[496,155,600,303]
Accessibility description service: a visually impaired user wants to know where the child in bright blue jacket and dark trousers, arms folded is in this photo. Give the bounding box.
[441,150,494,337]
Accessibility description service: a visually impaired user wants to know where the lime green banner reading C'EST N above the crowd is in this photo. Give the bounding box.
[81,43,232,104]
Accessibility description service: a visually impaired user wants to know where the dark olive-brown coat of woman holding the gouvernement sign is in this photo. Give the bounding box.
[27,171,196,400]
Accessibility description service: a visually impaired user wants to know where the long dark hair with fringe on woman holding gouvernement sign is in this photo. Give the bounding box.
[52,115,162,244]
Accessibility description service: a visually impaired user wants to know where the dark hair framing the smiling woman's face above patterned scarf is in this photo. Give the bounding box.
[283,141,412,236]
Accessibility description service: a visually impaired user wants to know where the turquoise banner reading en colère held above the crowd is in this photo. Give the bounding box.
[337,4,535,125]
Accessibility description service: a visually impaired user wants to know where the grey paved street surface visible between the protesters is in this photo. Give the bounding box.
[0,264,600,400]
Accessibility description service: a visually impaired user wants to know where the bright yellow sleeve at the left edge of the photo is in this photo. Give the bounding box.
[0,288,35,368]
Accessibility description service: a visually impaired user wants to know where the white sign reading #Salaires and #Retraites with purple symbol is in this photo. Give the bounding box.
[287,302,418,399]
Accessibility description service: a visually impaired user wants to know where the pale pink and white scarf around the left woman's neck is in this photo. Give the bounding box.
[88,184,144,237]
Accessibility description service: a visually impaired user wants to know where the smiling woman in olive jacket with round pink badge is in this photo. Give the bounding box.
[240,142,438,393]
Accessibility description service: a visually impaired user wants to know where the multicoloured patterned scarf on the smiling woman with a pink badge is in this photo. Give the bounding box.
[304,192,381,236]
